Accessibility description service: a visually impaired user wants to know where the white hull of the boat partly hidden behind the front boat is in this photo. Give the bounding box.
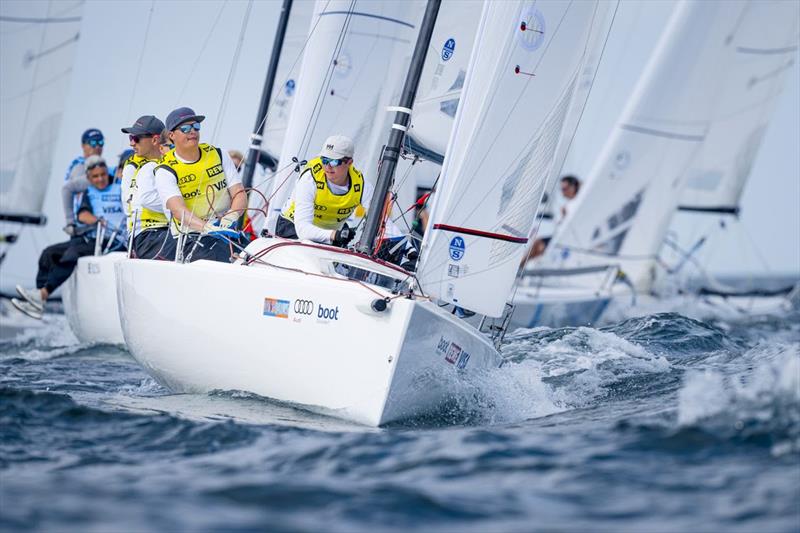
[62,252,126,344]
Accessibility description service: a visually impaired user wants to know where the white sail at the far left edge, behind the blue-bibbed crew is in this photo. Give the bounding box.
[0,1,83,216]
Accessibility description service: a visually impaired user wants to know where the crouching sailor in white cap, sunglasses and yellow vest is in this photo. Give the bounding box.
[275,135,372,247]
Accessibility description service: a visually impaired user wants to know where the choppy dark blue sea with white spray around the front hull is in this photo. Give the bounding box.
[0,302,800,532]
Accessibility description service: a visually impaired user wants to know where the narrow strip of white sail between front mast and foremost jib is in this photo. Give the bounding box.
[405,0,483,164]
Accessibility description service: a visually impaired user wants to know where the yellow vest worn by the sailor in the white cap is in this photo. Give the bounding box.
[281,157,364,230]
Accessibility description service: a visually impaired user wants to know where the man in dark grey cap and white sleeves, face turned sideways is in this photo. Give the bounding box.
[122,115,175,259]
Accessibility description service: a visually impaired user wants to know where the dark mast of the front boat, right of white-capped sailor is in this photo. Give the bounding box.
[356,0,441,254]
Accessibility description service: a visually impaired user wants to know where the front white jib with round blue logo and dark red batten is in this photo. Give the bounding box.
[418,1,598,316]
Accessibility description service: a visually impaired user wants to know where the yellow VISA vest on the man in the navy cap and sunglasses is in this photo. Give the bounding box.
[156,143,231,235]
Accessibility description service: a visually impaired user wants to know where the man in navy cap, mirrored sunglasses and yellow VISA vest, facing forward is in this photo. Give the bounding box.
[154,107,247,262]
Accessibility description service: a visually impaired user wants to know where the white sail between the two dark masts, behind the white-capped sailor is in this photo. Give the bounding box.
[267,0,422,231]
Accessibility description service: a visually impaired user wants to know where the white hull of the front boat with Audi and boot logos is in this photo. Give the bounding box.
[117,239,500,426]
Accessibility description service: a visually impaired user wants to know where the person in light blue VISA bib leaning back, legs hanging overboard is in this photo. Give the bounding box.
[11,155,125,319]
